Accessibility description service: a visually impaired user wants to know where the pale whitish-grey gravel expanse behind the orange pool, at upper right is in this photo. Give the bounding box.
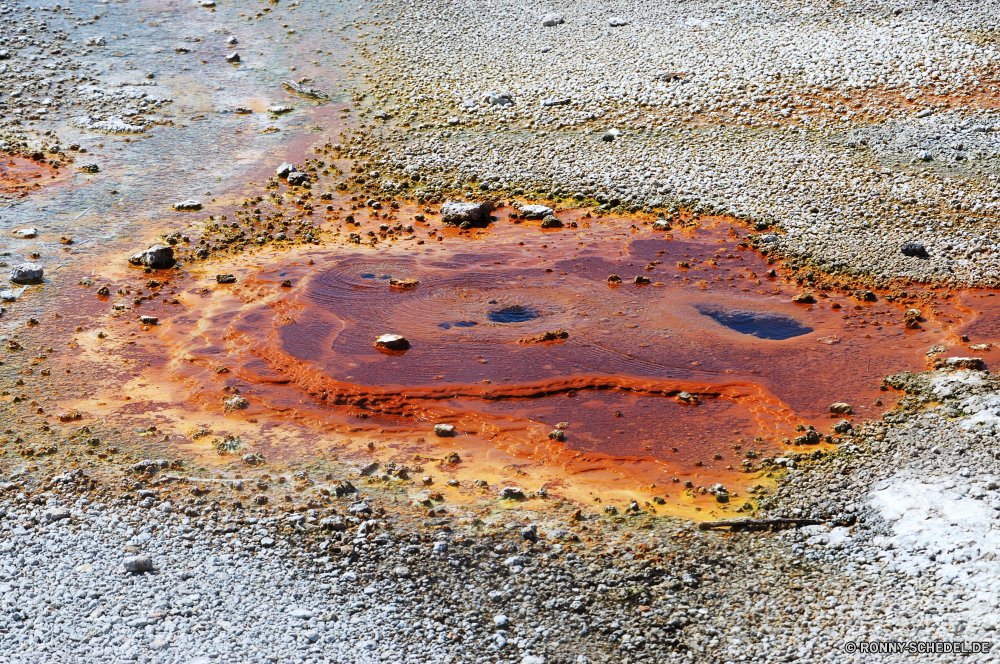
[344,1,998,286]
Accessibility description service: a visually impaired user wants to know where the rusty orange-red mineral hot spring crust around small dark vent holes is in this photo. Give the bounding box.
[148,211,992,498]
